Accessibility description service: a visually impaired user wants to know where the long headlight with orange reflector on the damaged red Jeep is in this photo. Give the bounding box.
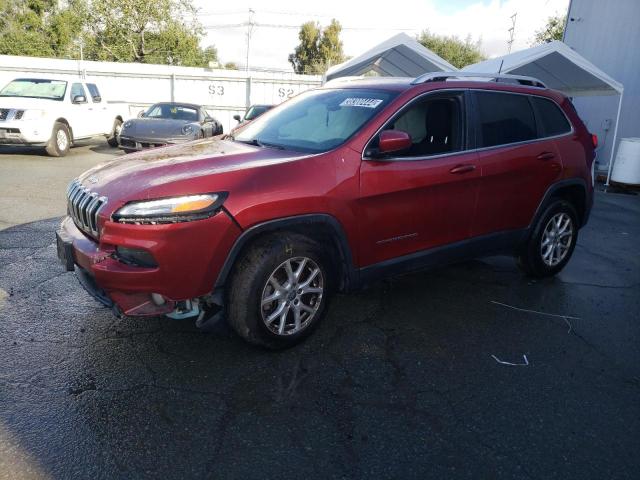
[113,192,227,224]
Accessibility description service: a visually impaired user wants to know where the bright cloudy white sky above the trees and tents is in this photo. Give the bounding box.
[194,0,569,70]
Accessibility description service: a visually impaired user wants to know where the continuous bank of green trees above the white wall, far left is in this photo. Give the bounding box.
[0,0,218,67]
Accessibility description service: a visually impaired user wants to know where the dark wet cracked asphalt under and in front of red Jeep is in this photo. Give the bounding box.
[0,193,640,479]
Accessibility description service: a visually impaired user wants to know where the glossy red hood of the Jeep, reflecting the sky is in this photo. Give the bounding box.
[78,138,309,208]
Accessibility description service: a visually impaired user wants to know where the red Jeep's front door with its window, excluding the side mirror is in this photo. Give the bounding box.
[359,90,480,266]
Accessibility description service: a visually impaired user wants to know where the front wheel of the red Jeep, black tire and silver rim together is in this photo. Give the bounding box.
[227,233,334,349]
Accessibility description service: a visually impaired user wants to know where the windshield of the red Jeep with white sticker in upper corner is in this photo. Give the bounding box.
[235,89,397,152]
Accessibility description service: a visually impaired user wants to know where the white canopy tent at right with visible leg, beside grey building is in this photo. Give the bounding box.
[462,40,624,185]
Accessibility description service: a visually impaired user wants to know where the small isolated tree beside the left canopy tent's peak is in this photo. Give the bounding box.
[289,19,344,75]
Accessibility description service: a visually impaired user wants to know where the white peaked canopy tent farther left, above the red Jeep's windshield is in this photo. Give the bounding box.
[326,33,458,81]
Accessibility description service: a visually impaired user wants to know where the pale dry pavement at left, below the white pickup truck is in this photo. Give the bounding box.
[0,139,122,230]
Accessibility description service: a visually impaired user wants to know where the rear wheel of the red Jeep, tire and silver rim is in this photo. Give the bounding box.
[518,199,578,278]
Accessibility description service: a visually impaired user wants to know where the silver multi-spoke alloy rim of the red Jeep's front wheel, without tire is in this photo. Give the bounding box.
[260,257,324,335]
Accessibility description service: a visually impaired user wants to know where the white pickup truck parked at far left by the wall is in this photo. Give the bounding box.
[0,78,123,157]
